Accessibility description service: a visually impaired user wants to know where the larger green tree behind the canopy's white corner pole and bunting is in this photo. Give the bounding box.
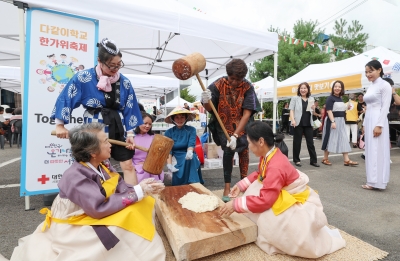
[250,20,329,82]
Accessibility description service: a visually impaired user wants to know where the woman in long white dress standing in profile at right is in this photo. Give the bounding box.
[362,60,392,189]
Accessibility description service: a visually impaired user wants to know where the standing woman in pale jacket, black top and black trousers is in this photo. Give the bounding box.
[289,82,319,167]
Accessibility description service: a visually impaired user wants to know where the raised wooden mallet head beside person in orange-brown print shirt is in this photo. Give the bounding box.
[172,53,206,80]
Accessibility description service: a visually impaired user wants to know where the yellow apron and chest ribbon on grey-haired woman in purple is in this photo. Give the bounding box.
[40,162,155,241]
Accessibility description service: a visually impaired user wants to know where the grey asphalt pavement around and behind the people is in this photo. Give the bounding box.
[0,137,400,261]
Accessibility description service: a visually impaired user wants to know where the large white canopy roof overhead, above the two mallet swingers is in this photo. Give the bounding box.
[0,0,278,77]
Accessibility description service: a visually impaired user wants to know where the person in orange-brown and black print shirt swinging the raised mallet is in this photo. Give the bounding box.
[202,59,261,202]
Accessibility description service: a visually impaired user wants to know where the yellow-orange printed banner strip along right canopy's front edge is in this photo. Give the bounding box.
[278,74,362,97]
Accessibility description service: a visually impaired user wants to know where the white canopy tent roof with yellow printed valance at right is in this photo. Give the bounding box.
[278,47,400,98]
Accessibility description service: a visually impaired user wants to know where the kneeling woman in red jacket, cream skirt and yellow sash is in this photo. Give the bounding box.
[220,121,346,258]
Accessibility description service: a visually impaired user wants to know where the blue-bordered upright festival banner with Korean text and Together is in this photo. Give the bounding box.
[20,8,98,196]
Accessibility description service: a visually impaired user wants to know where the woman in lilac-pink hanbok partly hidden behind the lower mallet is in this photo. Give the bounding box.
[132,112,164,182]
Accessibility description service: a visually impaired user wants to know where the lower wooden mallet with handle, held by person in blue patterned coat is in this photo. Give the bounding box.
[51,130,174,175]
